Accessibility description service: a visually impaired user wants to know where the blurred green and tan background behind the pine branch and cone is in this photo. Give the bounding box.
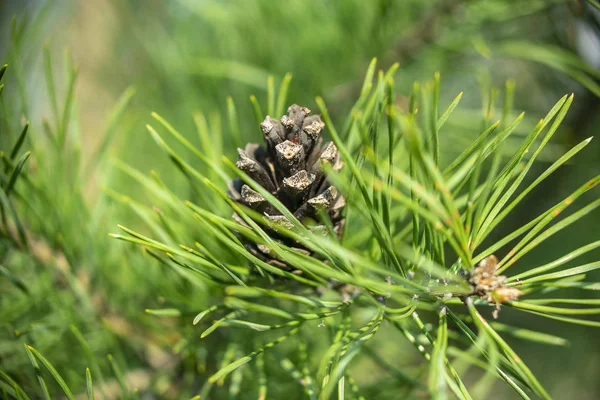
[0,0,600,400]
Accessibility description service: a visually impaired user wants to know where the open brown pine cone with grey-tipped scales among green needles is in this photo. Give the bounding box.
[228,104,346,269]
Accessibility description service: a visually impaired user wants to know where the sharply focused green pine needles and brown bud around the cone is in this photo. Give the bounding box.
[105,62,600,399]
